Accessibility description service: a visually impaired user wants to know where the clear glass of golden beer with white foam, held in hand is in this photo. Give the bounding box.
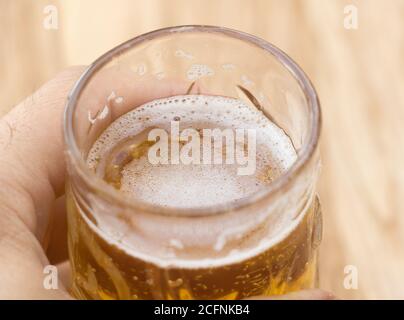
[64,26,322,299]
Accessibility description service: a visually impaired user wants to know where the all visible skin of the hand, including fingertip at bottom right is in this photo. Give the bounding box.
[0,67,333,299]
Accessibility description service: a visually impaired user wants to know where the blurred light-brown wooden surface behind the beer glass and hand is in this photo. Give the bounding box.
[0,0,404,299]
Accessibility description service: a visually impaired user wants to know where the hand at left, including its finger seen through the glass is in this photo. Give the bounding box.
[0,67,199,299]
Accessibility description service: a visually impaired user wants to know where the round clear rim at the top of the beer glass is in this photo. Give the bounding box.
[63,25,321,217]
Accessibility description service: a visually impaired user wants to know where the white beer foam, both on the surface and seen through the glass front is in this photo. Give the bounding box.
[86,95,304,268]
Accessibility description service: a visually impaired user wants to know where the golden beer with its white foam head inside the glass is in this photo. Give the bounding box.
[68,95,321,299]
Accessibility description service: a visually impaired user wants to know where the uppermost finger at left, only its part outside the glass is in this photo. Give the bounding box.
[0,67,84,241]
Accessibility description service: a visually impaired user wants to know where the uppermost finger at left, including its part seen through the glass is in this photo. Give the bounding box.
[0,67,196,240]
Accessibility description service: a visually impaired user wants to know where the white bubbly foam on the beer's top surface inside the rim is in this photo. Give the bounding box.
[87,95,296,207]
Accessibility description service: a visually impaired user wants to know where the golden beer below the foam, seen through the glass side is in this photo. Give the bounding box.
[69,200,321,300]
